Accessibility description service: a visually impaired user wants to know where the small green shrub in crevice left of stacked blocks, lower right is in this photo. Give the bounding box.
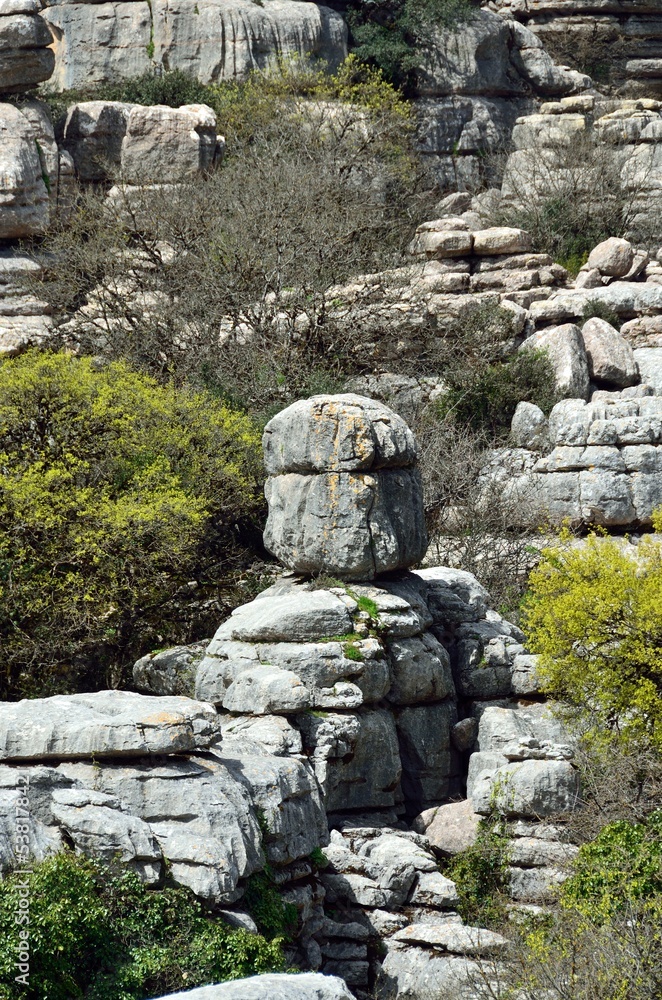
[444,823,509,927]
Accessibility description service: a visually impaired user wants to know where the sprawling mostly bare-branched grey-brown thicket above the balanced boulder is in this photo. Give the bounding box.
[33,59,425,417]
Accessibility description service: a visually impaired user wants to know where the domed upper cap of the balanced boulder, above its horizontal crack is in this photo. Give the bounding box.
[263,393,416,476]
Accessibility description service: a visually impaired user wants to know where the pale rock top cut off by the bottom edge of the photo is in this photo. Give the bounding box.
[153,972,353,1000]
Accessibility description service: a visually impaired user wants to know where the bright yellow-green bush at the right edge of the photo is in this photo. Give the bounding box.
[523,514,662,748]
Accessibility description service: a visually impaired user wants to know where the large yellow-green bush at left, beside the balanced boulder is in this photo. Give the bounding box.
[0,351,261,698]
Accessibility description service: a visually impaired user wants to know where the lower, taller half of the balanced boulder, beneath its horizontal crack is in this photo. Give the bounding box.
[264,468,427,580]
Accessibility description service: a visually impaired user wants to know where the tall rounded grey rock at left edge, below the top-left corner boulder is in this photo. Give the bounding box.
[0,103,50,239]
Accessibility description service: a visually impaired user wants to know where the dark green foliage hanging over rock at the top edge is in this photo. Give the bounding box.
[347,0,473,91]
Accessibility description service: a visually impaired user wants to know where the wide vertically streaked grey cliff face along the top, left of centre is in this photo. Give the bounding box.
[44,0,347,90]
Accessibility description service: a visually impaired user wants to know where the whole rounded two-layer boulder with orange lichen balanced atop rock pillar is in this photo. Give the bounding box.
[263,394,427,580]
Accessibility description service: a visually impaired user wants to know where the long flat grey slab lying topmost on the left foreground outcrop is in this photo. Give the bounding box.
[0,691,221,760]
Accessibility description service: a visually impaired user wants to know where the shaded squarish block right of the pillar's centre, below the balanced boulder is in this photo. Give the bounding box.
[387,632,455,705]
